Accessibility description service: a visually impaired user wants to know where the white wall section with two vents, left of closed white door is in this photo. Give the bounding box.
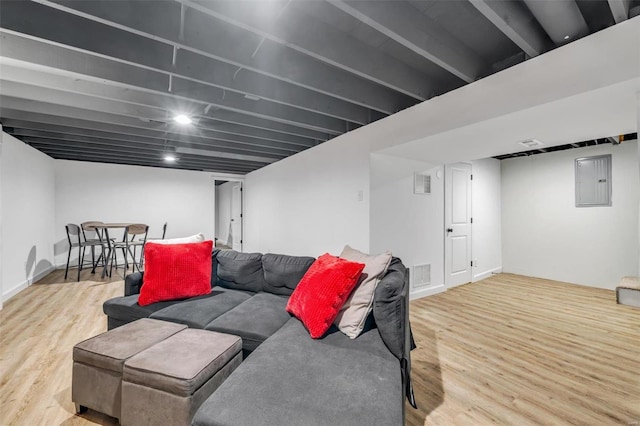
[370,154,444,298]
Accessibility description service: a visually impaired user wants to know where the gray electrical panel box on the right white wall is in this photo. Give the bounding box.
[576,154,611,207]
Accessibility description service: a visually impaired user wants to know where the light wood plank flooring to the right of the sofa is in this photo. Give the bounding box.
[407,274,640,425]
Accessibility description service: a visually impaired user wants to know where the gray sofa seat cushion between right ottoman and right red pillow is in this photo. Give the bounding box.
[204,293,291,352]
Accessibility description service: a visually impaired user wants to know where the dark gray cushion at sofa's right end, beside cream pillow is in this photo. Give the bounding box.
[373,257,408,359]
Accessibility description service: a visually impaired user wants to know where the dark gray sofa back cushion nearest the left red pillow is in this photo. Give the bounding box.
[216,250,264,293]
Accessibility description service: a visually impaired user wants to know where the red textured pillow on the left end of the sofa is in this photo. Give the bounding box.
[138,241,213,306]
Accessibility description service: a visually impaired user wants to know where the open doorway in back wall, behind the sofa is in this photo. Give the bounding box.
[215,179,243,251]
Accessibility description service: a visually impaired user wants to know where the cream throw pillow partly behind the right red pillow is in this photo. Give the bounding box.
[333,245,392,339]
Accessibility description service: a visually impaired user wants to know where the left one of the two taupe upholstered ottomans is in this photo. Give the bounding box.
[71,318,187,418]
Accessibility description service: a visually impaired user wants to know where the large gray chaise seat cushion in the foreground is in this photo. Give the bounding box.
[192,318,403,426]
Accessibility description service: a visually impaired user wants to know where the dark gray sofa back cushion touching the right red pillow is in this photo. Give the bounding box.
[262,253,315,296]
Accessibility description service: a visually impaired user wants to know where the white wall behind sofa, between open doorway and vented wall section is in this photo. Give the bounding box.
[244,135,369,256]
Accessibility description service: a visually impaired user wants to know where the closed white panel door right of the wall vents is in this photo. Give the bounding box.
[444,163,472,288]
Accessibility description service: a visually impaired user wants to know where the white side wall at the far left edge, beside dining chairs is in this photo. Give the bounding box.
[0,133,55,301]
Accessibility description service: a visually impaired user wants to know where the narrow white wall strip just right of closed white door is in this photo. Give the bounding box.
[471,158,502,281]
